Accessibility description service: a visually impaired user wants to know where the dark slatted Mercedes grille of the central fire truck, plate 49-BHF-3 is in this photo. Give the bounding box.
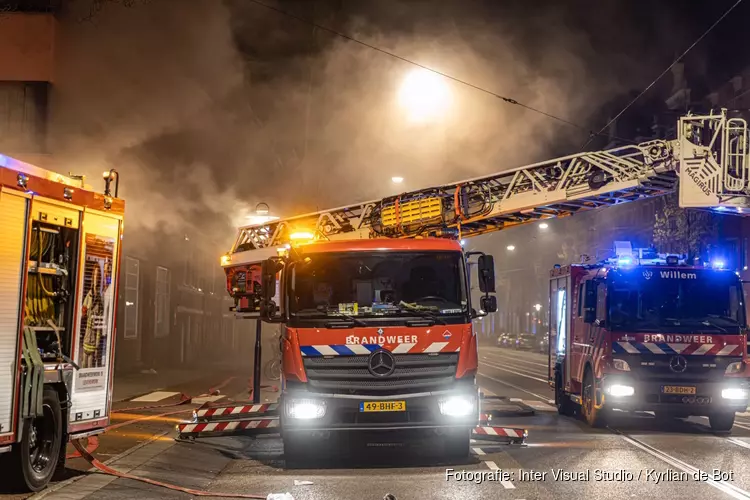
[304,353,458,394]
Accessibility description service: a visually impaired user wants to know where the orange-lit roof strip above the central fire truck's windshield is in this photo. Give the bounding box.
[299,238,461,253]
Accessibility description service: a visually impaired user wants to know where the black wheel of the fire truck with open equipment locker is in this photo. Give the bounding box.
[8,388,63,491]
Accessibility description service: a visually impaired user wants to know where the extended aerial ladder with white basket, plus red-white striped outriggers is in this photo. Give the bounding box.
[178,110,750,442]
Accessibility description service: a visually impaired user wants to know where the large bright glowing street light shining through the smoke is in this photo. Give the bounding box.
[398,68,451,123]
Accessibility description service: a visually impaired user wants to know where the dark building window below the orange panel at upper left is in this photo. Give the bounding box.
[0,82,49,155]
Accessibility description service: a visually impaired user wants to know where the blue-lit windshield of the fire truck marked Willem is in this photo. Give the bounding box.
[607,268,745,334]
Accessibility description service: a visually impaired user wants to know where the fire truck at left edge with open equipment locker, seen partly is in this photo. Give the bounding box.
[0,155,124,491]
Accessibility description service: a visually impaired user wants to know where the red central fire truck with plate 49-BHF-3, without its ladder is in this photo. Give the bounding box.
[229,232,497,461]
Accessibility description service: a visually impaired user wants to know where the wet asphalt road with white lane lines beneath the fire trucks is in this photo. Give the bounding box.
[13,347,750,500]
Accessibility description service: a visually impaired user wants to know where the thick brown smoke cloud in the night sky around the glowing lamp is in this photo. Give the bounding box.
[51,0,692,250]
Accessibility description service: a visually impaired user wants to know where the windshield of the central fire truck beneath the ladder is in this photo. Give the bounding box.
[288,251,468,321]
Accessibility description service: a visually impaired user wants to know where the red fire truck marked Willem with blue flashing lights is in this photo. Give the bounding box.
[549,242,750,432]
